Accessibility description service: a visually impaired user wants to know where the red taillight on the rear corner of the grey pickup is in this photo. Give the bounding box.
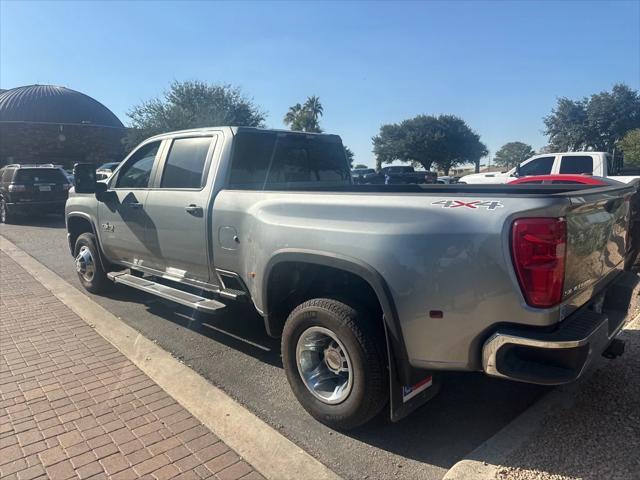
[511,218,567,308]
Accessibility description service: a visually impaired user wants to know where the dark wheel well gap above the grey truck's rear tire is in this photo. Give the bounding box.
[267,262,383,336]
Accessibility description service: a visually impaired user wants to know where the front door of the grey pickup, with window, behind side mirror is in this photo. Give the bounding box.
[98,140,162,264]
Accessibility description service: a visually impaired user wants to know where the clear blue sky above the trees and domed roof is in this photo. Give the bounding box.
[0,0,640,165]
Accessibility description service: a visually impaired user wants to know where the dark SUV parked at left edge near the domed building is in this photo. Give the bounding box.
[0,164,71,223]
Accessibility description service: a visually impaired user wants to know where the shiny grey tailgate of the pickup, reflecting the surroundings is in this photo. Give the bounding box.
[563,187,633,300]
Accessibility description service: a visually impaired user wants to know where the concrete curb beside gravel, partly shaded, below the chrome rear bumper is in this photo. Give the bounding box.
[443,306,640,480]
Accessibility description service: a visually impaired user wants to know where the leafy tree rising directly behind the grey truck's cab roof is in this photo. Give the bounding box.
[127,81,265,147]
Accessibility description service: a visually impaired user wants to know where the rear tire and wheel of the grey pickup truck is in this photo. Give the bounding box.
[282,298,389,430]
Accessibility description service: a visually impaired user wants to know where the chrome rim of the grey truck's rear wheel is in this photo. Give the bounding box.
[296,327,353,405]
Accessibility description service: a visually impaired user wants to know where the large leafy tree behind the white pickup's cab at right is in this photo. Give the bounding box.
[544,84,640,152]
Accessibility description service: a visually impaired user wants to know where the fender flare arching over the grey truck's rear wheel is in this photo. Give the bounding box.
[261,248,412,385]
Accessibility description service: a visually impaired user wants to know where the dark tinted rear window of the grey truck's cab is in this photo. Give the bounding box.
[229,132,351,190]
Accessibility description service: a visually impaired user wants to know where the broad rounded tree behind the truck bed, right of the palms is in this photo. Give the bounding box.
[372,115,488,175]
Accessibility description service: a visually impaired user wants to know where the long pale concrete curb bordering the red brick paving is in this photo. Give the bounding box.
[0,235,340,480]
